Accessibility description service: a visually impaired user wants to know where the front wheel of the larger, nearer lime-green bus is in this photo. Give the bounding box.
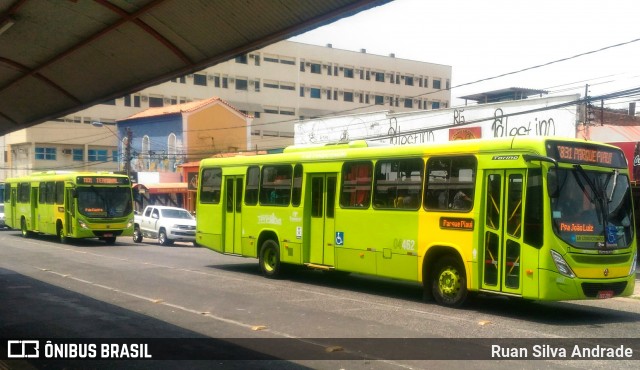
[431,255,469,307]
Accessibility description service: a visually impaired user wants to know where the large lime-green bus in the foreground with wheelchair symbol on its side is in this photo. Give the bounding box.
[196,137,637,306]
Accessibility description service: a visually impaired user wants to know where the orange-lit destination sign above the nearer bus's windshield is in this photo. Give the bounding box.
[547,142,627,168]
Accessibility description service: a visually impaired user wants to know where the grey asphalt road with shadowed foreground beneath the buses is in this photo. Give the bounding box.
[0,231,640,369]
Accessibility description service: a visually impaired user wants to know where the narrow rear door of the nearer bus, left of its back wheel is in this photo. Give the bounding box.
[223,176,244,254]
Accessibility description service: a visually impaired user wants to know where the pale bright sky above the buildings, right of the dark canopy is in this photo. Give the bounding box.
[292,0,640,108]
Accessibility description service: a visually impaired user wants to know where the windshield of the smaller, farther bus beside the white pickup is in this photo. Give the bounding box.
[77,186,133,218]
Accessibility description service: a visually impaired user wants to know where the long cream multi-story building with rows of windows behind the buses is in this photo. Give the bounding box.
[0,41,451,178]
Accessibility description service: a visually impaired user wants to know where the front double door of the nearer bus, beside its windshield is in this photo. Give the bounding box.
[480,170,525,295]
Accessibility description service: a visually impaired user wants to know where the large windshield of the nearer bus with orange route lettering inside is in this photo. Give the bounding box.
[549,165,633,249]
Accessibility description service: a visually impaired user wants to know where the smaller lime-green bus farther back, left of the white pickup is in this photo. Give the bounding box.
[4,171,133,244]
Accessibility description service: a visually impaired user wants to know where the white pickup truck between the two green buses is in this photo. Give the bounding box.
[133,206,196,245]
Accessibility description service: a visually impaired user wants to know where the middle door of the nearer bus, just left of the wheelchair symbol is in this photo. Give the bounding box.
[307,173,338,266]
